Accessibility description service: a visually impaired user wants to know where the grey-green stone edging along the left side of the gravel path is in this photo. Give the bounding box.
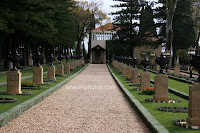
[0,65,88,127]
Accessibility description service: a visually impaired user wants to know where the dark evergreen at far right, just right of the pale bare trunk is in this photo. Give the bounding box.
[173,0,195,55]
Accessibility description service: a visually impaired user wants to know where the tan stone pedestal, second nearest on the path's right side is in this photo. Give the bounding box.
[153,74,169,101]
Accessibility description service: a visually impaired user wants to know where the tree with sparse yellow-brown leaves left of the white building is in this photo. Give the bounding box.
[73,1,107,55]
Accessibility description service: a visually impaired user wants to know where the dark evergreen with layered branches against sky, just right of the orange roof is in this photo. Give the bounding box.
[111,0,141,56]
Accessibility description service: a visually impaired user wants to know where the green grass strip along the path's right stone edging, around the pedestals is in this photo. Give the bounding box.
[111,67,200,133]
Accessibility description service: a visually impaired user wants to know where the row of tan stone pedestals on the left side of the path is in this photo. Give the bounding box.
[7,51,84,94]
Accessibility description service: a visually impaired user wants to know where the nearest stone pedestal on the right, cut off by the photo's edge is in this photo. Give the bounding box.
[186,82,200,126]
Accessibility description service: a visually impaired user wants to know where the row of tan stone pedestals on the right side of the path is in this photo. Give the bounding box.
[112,60,200,126]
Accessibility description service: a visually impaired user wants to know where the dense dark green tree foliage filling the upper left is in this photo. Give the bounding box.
[0,0,75,68]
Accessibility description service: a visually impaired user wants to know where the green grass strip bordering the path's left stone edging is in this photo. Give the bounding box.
[0,65,84,113]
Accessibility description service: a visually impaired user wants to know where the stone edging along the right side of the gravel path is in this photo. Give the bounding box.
[107,65,169,133]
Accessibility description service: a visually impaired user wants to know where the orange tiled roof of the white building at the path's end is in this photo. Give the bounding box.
[92,23,120,31]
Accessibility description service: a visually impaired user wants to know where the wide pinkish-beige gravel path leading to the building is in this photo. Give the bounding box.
[0,64,150,133]
